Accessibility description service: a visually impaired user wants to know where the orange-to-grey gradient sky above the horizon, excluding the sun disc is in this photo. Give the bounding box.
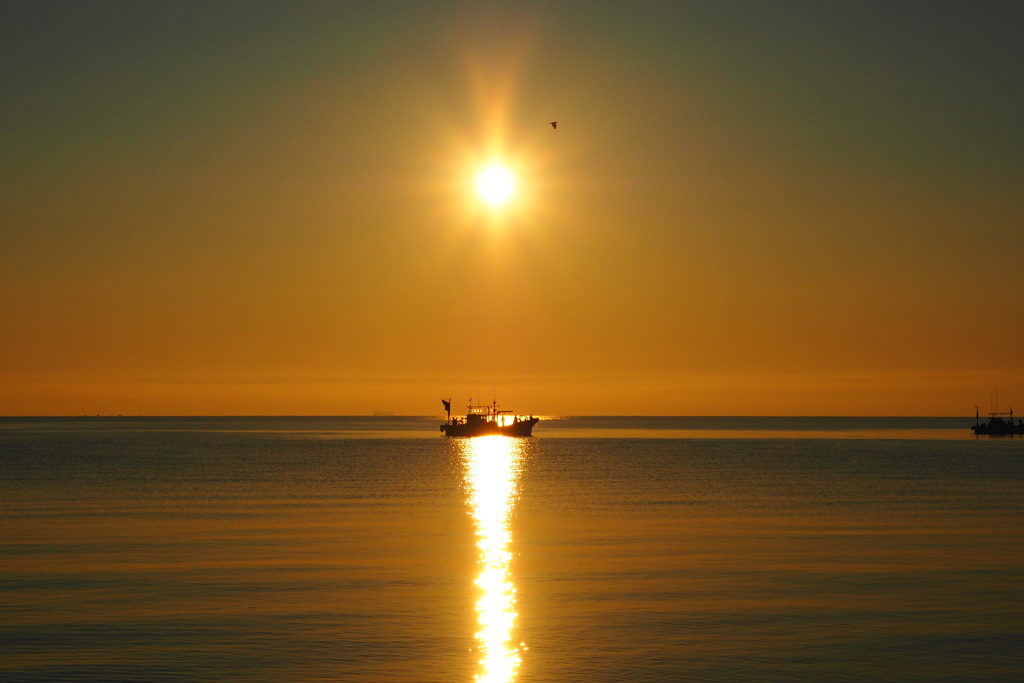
[0,1,1024,417]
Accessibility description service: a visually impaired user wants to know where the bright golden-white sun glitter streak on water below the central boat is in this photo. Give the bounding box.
[459,436,522,683]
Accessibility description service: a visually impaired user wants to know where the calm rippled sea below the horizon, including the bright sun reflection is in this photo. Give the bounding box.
[0,418,1024,682]
